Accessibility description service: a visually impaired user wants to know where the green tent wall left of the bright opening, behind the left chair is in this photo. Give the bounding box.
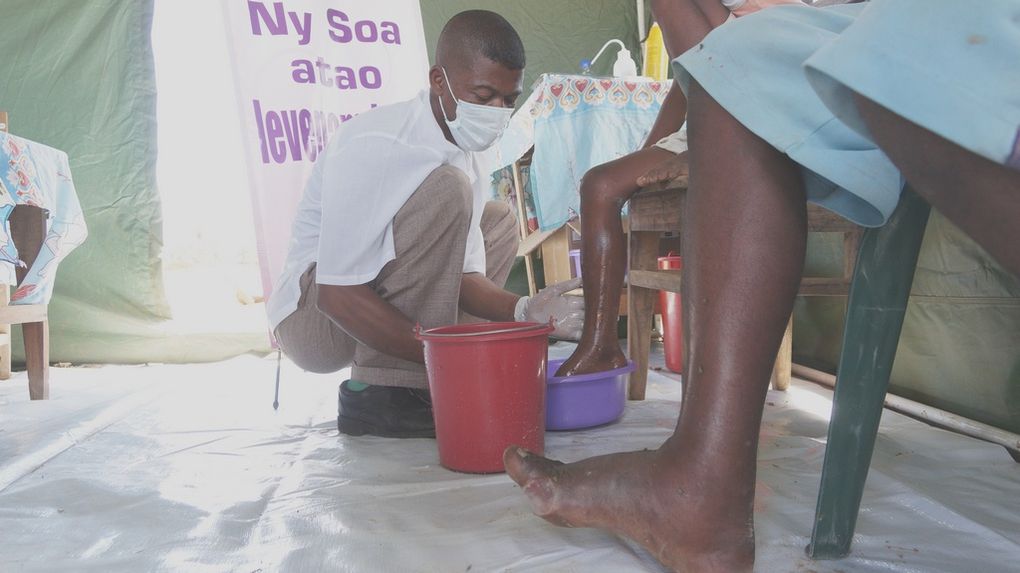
[0,0,169,362]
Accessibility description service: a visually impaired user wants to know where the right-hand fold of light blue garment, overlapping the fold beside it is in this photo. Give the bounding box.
[805,0,1020,169]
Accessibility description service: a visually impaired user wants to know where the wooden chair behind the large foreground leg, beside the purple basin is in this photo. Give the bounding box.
[627,177,863,400]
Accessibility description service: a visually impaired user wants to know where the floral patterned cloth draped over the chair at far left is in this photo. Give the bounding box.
[0,132,88,305]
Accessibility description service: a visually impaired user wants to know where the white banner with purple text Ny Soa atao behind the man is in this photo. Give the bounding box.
[221,0,428,307]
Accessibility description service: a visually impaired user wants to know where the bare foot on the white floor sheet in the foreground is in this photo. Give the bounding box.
[503,447,755,573]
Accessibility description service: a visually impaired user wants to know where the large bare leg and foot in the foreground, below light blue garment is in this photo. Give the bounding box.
[504,80,806,573]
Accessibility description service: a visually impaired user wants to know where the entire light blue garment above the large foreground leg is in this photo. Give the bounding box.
[673,0,1020,226]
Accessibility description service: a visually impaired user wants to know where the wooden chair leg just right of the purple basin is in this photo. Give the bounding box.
[627,231,659,400]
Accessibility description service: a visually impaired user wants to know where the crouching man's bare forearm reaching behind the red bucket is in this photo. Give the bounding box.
[316,284,425,364]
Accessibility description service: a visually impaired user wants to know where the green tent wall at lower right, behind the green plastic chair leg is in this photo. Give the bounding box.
[794,215,1020,433]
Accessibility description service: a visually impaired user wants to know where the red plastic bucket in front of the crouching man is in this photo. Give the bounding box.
[418,322,553,473]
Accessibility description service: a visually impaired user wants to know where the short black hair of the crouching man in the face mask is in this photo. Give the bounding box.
[436,10,525,70]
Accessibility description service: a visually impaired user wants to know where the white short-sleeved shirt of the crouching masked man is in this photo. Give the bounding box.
[267,91,492,329]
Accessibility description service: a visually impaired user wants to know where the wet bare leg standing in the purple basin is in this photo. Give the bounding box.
[557,147,674,376]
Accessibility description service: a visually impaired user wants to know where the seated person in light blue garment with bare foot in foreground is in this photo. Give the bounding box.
[504,0,1020,573]
